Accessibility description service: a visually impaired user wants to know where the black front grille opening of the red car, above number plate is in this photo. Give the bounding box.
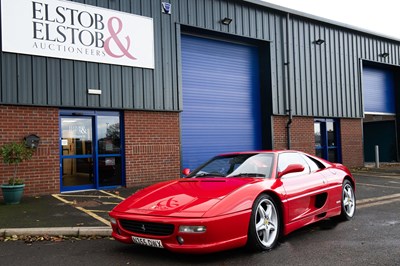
[120,220,174,236]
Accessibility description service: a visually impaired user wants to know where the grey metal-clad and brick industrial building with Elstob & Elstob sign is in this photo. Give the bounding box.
[0,0,400,195]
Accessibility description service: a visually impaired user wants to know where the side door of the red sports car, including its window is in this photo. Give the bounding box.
[278,152,327,223]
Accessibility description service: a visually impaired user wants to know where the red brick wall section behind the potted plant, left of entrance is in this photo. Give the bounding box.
[0,105,60,195]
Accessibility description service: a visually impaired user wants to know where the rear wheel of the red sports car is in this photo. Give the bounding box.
[336,179,356,221]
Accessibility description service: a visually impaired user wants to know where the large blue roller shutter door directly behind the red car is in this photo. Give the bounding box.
[181,35,261,169]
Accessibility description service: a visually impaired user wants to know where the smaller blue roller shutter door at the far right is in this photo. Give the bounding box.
[363,67,396,114]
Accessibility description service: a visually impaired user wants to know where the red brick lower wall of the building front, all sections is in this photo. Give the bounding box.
[0,105,363,195]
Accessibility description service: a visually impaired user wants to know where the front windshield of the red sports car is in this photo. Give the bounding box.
[187,153,274,178]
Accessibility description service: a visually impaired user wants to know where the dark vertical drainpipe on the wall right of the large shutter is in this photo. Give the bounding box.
[285,13,293,150]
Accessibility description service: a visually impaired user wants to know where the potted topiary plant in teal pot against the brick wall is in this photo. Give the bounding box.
[0,142,33,204]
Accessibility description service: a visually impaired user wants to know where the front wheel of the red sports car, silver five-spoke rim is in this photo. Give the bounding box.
[247,194,281,251]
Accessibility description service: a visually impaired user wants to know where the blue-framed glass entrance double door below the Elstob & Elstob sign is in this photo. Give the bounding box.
[60,112,123,191]
